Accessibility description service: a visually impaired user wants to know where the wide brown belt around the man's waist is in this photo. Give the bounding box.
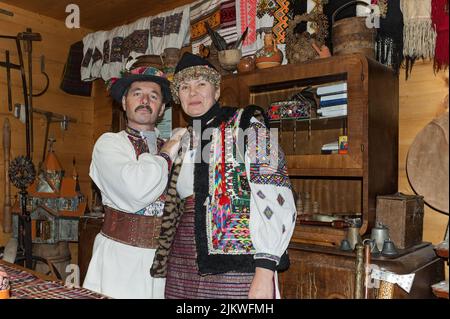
[102,206,162,249]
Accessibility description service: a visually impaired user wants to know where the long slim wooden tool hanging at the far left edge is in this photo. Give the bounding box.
[3,117,12,233]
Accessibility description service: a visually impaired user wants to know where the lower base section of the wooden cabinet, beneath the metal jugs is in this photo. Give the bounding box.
[279,243,444,299]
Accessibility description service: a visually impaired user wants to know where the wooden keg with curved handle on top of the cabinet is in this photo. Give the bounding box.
[331,1,376,59]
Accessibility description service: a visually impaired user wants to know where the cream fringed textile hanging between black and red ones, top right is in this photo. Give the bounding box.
[400,0,436,79]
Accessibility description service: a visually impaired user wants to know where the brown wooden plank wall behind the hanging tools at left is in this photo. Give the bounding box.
[0,2,94,257]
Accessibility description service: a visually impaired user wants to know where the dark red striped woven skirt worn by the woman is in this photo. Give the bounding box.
[165,197,253,299]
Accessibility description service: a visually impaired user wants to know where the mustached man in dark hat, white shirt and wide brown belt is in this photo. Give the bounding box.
[83,67,184,298]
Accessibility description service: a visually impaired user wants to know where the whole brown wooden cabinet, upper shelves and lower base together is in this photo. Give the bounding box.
[217,54,444,298]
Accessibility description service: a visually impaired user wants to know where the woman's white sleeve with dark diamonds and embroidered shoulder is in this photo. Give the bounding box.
[245,118,297,270]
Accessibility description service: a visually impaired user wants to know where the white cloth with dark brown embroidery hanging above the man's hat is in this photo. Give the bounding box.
[81,5,190,81]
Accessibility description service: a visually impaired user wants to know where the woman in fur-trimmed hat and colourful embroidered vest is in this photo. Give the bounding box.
[151,53,296,299]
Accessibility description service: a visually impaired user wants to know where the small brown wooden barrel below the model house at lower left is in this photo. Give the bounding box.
[33,241,71,280]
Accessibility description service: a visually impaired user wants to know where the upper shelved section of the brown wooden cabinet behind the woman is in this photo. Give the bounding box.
[221,54,399,246]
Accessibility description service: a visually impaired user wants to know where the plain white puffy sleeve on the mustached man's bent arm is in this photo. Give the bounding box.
[89,133,168,213]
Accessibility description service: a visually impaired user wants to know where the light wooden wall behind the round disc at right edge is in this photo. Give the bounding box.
[398,62,448,244]
